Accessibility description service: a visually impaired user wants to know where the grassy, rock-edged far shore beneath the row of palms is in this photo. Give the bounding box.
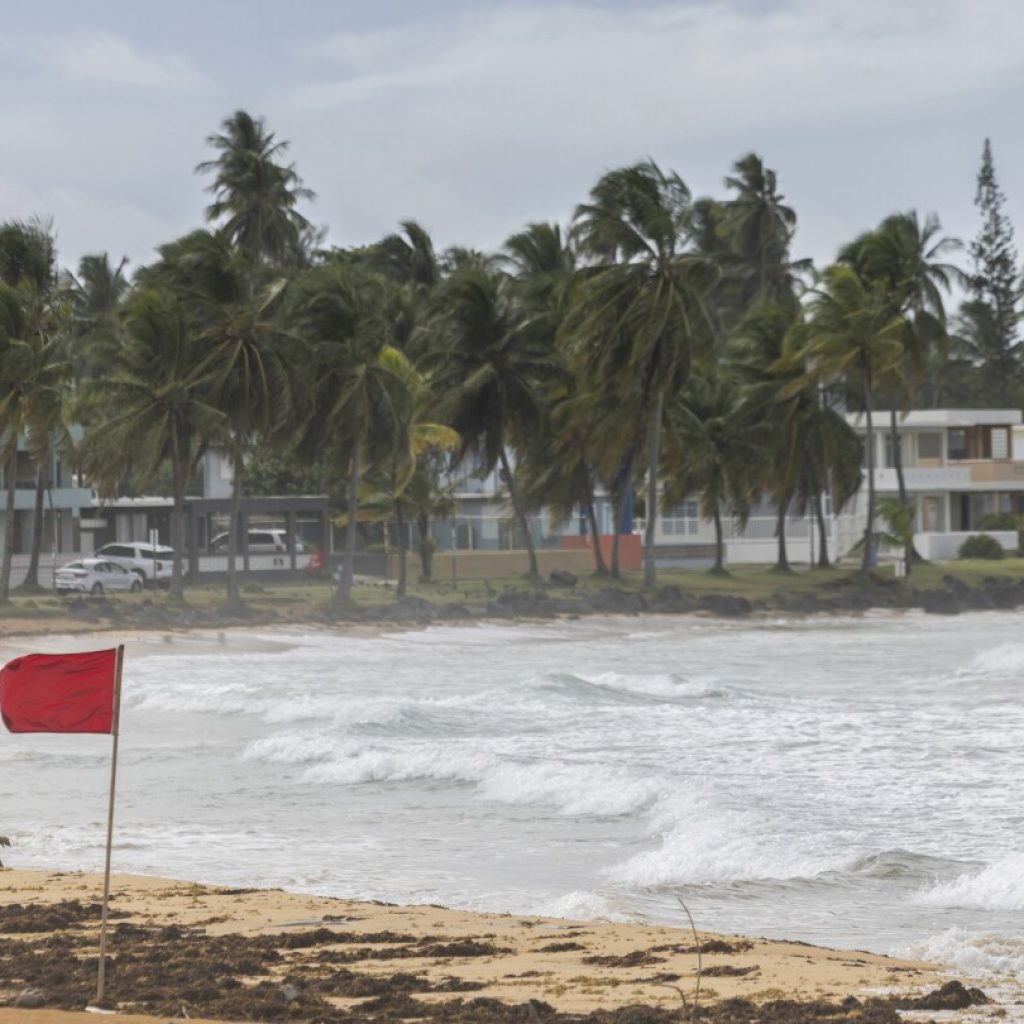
[0,563,1024,640]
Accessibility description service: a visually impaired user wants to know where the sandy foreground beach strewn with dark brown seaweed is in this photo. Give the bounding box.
[0,868,987,1024]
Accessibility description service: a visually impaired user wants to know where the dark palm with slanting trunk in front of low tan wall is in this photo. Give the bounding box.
[434,265,556,581]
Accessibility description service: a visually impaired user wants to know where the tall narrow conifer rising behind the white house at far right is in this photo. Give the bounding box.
[961,138,1021,408]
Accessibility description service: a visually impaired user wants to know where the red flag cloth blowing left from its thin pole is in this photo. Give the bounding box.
[0,647,117,732]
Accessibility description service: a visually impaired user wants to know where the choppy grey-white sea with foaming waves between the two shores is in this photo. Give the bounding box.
[0,613,1024,980]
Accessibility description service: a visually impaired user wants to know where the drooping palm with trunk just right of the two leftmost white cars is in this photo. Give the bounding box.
[79,288,224,600]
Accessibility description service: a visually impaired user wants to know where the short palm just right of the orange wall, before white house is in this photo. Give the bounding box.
[664,372,763,573]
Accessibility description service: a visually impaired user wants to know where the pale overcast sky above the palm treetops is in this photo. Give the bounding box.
[0,0,1024,276]
